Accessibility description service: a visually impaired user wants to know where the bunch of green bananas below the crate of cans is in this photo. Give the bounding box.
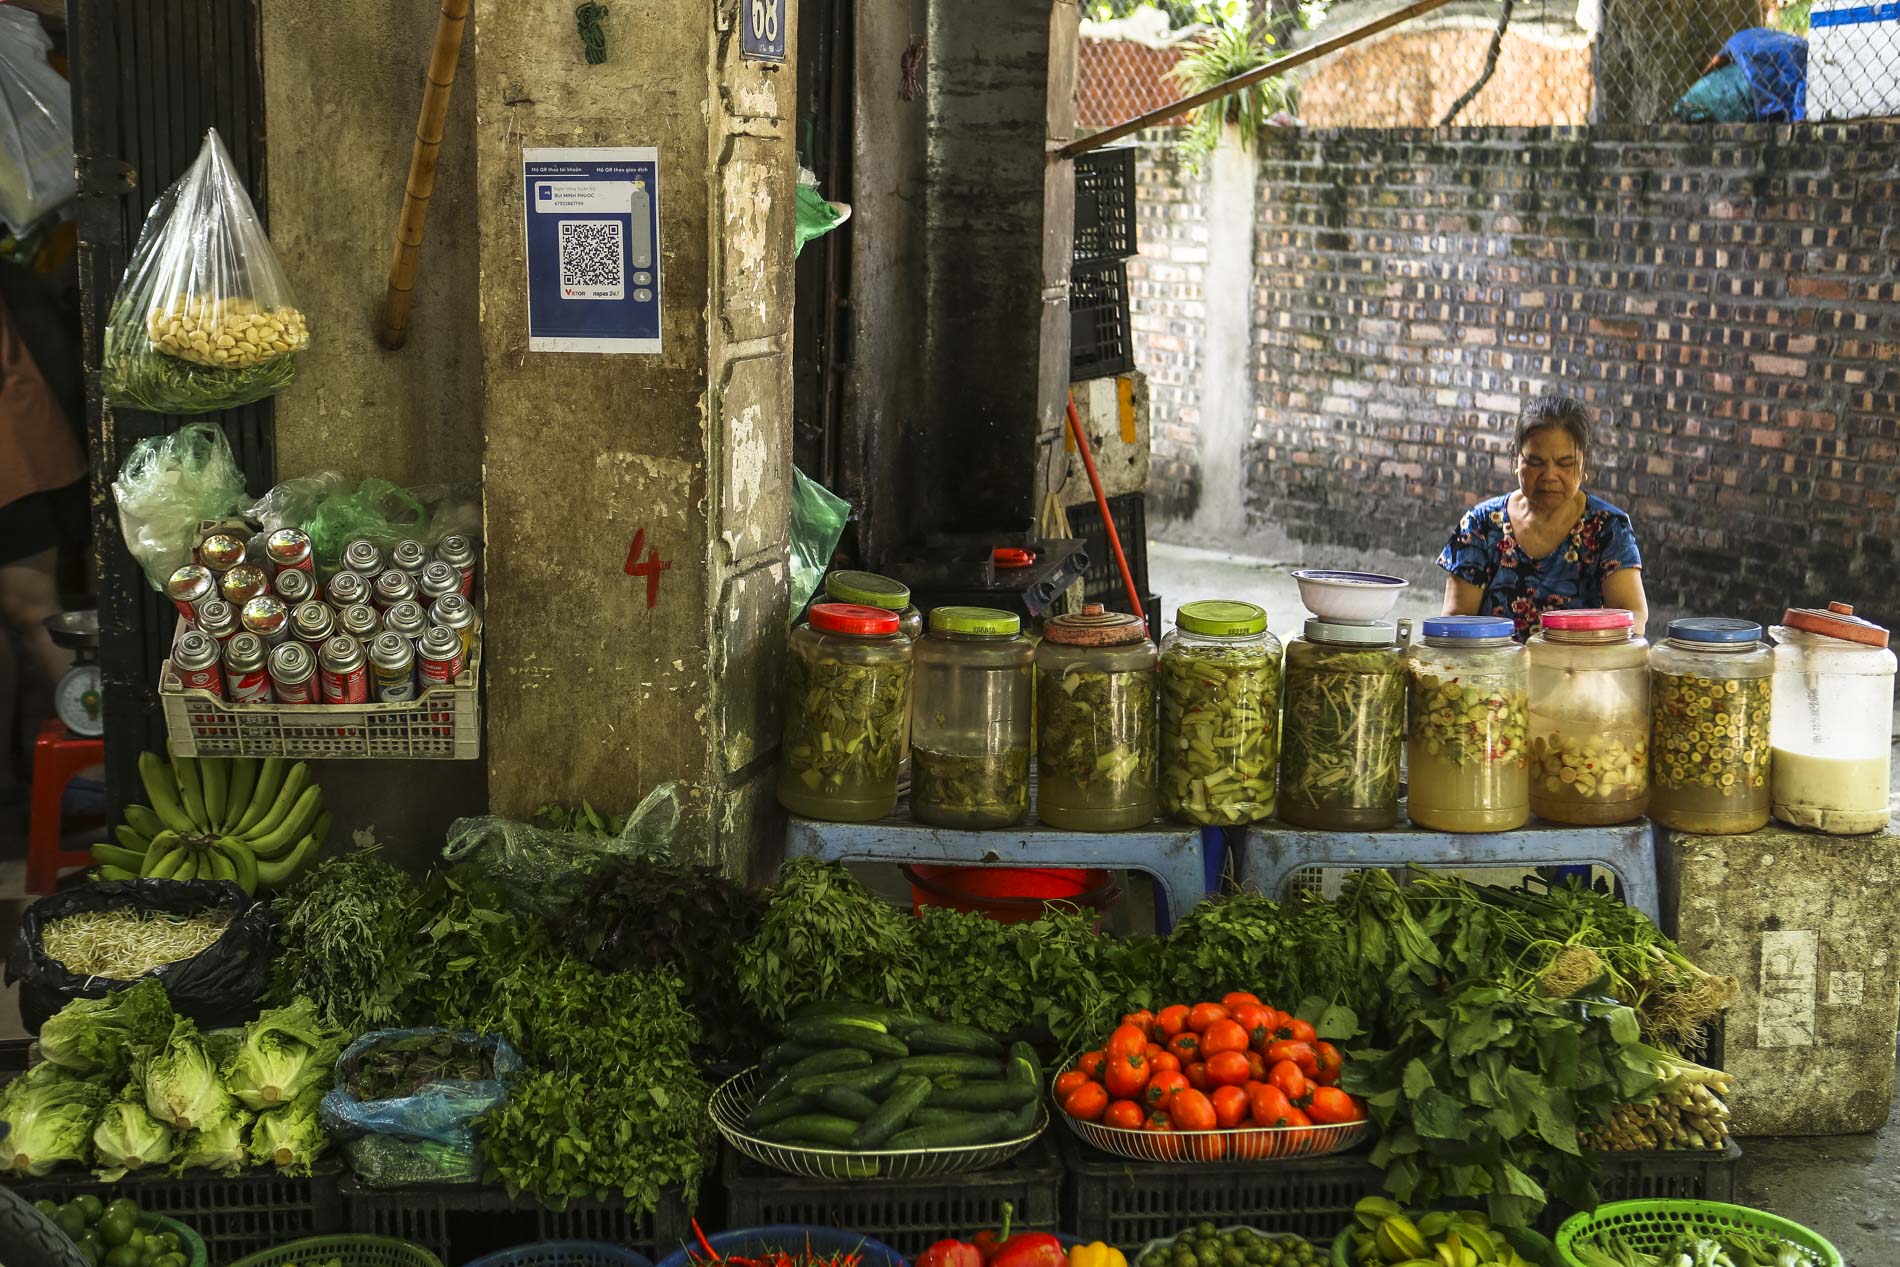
[93,752,331,895]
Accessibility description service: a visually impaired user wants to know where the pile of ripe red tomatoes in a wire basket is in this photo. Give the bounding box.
[1055,993,1366,1161]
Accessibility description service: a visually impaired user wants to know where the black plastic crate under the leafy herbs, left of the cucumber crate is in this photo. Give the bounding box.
[342,1180,692,1263]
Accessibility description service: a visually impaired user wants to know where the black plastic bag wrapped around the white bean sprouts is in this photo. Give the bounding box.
[6,879,277,1033]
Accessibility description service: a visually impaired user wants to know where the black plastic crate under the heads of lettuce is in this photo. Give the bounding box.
[11,1170,350,1267]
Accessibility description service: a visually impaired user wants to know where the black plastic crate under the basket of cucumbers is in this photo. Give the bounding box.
[722,1126,1064,1258]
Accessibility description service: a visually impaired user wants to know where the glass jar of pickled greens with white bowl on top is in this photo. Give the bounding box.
[1279,617,1406,830]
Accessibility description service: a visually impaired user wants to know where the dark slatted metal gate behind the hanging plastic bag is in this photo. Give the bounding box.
[68,0,276,809]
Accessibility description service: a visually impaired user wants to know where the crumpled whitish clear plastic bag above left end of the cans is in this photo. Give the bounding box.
[112,422,245,591]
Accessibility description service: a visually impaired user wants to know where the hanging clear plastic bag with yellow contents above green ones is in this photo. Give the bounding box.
[103,129,310,414]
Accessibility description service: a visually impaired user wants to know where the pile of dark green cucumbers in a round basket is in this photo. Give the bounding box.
[745,1003,1043,1153]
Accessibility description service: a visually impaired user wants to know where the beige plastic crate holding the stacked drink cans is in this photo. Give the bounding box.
[158,634,481,762]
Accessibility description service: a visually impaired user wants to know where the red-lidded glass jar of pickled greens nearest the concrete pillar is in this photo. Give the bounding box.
[779,602,910,823]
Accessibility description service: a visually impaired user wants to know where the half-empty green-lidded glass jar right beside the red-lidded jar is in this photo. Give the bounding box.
[910,608,1036,828]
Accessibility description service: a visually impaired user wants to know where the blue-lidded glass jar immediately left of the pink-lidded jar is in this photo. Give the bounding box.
[1406,615,1531,832]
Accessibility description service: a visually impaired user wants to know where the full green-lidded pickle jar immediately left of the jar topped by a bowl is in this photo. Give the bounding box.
[1161,600,1281,826]
